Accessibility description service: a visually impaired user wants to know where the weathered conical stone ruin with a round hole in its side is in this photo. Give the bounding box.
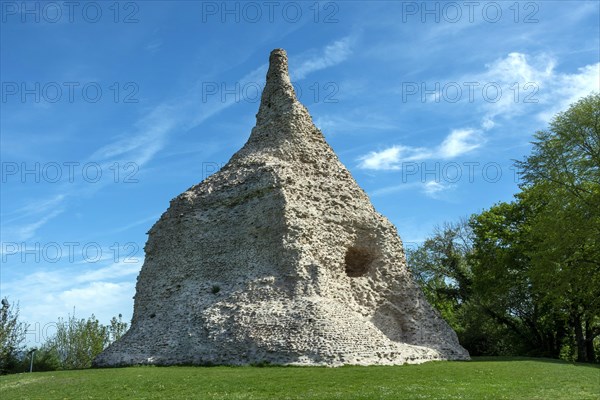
[94,49,469,366]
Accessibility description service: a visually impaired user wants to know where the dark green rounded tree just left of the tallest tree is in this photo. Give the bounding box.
[471,201,565,357]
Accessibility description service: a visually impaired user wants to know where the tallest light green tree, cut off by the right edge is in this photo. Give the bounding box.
[517,94,600,361]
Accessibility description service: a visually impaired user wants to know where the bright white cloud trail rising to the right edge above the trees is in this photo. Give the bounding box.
[359,52,600,172]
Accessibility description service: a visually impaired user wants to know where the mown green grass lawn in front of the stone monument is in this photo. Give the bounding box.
[0,358,600,400]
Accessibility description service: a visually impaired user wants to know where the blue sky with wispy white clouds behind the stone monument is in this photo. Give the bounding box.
[0,1,600,343]
